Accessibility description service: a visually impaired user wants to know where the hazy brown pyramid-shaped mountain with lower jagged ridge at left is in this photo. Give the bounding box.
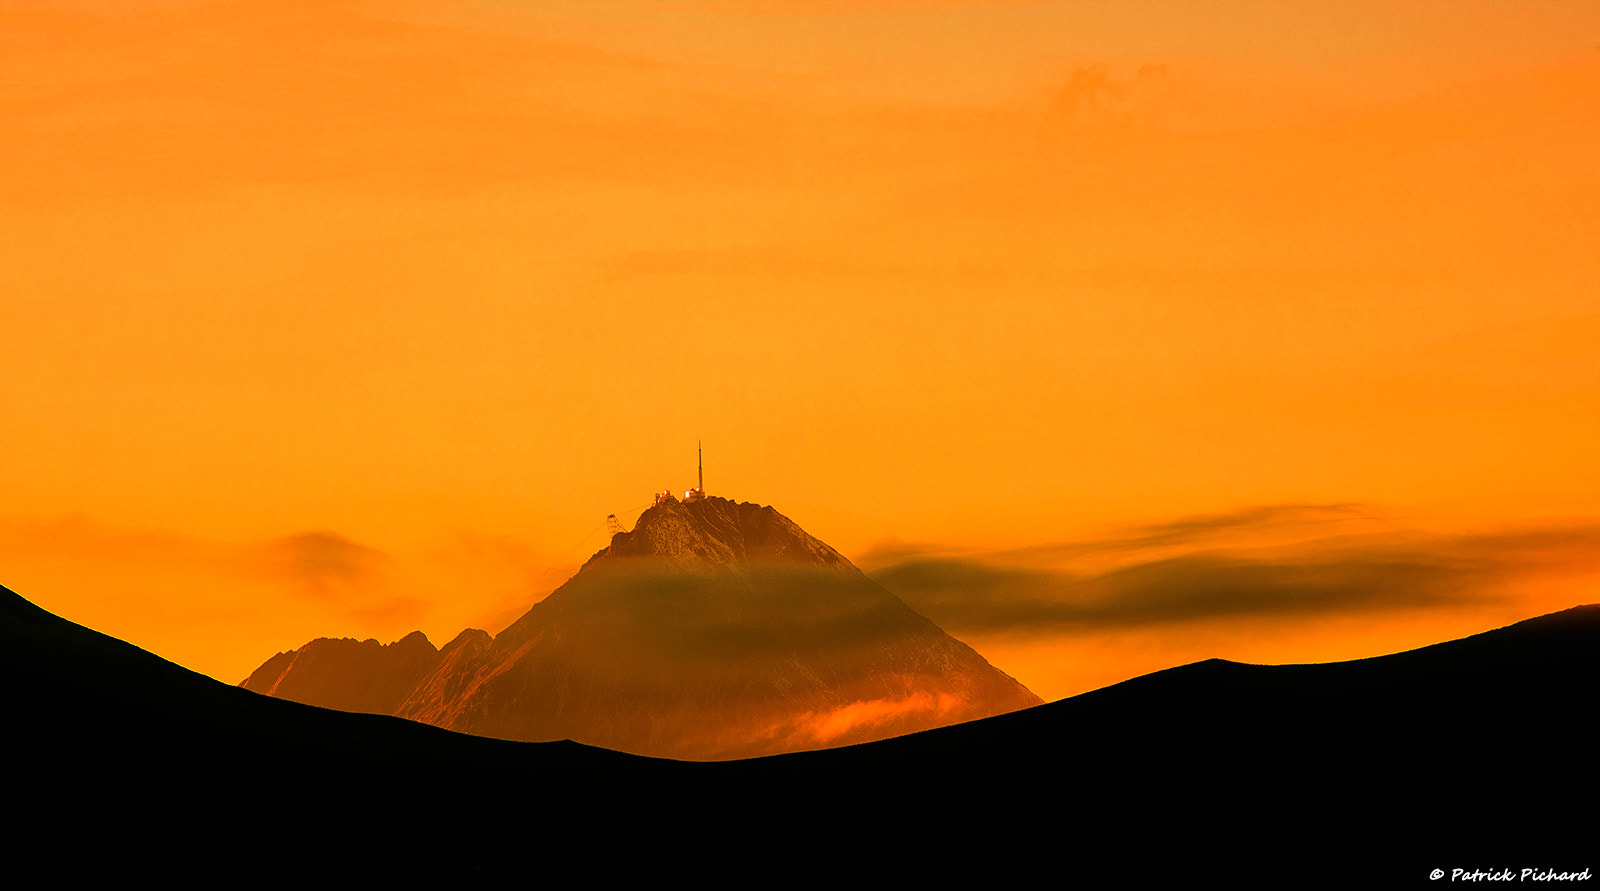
[243,496,1040,760]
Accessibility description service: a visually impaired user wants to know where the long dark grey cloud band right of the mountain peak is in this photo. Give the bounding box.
[869,504,1600,637]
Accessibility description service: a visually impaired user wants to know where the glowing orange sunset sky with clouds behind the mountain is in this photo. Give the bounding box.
[0,0,1600,699]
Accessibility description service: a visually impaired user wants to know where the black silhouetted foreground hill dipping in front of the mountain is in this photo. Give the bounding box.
[0,589,1600,888]
